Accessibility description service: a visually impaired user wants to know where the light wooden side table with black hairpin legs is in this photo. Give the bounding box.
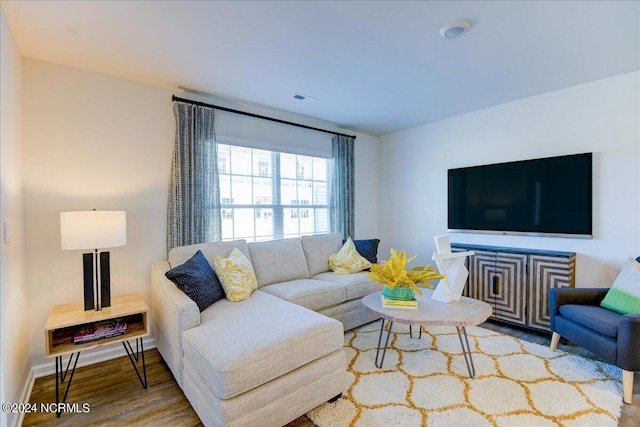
[44,294,149,417]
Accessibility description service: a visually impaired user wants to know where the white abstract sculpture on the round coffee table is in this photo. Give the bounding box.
[431,234,475,303]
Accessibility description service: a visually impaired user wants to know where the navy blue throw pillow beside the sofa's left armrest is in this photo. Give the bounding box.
[165,250,225,312]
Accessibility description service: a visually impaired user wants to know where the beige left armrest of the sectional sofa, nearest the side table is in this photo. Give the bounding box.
[151,261,200,387]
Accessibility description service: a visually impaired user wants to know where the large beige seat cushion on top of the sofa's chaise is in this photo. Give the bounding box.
[182,290,344,399]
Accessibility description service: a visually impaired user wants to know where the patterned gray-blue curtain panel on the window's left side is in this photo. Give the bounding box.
[167,101,221,252]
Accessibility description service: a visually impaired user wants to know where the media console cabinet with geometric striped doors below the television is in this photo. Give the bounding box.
[451,243,576,332]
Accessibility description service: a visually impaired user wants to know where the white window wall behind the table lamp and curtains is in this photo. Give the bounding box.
[23,59,378,372]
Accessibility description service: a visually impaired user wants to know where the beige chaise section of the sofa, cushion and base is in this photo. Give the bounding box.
[182,291,347,426]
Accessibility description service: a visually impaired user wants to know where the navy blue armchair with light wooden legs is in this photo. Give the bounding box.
[549,288,640,404]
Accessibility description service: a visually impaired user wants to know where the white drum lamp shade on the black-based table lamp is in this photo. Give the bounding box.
[60,211,127,250]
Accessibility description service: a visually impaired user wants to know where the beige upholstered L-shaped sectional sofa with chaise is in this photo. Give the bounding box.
[151,233,382,427]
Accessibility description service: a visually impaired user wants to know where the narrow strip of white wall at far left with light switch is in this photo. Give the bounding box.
[0,5,30,426]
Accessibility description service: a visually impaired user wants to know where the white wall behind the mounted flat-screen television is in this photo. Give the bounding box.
[379,72,640,287]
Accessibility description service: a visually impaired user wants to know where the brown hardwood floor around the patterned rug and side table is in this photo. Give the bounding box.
[23,322,640,427]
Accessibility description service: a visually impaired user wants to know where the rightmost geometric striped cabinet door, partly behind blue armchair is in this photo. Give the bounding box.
[527,254,576,331]
